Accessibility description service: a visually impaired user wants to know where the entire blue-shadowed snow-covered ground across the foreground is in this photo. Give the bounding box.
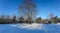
[0,23,60,33]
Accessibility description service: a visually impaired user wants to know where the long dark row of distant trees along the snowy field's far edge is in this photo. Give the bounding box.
[0,15,60,24]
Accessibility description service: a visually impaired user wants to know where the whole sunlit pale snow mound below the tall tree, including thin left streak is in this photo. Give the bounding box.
[12,23,43,30]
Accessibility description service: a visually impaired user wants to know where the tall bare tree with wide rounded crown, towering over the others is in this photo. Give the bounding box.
[19,0,38,22]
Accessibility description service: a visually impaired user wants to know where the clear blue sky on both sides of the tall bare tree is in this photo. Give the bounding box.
[0,0,60,18]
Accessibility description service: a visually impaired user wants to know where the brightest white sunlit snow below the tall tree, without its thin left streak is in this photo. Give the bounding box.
[19,23,43,30]
